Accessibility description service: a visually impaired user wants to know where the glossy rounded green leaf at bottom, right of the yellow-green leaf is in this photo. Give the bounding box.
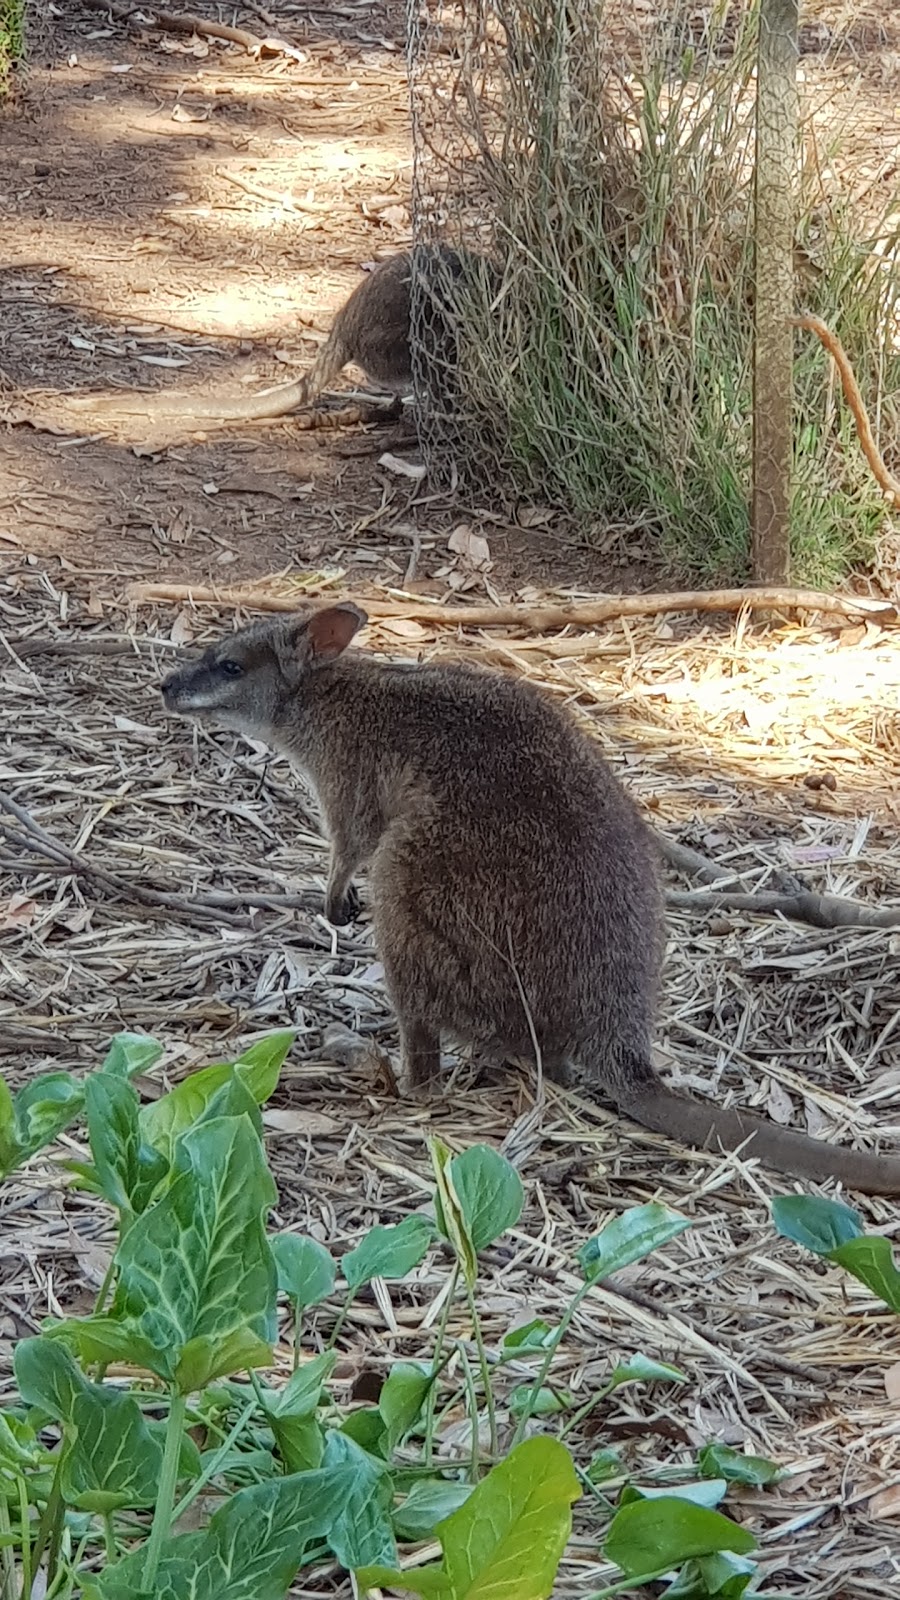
[604,1494,756,1578]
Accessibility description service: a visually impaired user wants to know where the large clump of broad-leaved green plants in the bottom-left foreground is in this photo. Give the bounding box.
[0,1032,778,1600]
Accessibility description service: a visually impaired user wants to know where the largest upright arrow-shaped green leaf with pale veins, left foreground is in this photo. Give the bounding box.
[108,1117,275,1394]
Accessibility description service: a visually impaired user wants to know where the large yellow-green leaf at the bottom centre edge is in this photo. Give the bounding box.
[357,1437,580,1600]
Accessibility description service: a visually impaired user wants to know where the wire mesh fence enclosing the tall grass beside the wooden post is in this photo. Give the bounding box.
[407,0,900,581]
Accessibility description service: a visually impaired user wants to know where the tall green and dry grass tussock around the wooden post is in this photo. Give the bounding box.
[431,0,900,584]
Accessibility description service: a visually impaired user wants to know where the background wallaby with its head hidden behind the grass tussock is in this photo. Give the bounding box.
[131,245,470,422]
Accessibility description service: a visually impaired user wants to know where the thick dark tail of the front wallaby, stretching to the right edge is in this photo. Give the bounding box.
[615,1062,900,1195]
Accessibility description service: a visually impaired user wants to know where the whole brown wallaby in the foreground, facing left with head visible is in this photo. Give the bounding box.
[157,603,900,1194]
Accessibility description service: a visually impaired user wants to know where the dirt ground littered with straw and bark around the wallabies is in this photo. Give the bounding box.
[0,0,900,1600]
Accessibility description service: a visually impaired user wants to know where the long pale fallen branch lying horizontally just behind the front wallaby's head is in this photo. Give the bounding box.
[125,584,898,634]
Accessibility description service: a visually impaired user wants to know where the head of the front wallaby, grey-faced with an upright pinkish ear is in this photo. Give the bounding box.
[162,602,368,739]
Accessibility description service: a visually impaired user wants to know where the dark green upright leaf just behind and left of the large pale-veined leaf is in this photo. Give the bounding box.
[85,1072,168,1219]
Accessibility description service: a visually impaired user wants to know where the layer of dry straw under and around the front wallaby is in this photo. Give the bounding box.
[0,576,900,1600]
